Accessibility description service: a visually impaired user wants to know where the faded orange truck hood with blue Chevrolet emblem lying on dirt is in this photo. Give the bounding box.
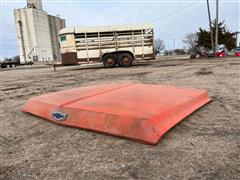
[22,83,211,145]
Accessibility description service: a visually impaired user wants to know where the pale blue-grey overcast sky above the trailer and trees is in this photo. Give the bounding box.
[0,0,240,58]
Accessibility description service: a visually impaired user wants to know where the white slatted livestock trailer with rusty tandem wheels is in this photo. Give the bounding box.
[59,24,155,67]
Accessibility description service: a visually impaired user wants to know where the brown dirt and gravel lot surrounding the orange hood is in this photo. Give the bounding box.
[0,58,240,180]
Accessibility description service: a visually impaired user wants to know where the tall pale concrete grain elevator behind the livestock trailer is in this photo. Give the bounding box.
[14,0,65,64]
